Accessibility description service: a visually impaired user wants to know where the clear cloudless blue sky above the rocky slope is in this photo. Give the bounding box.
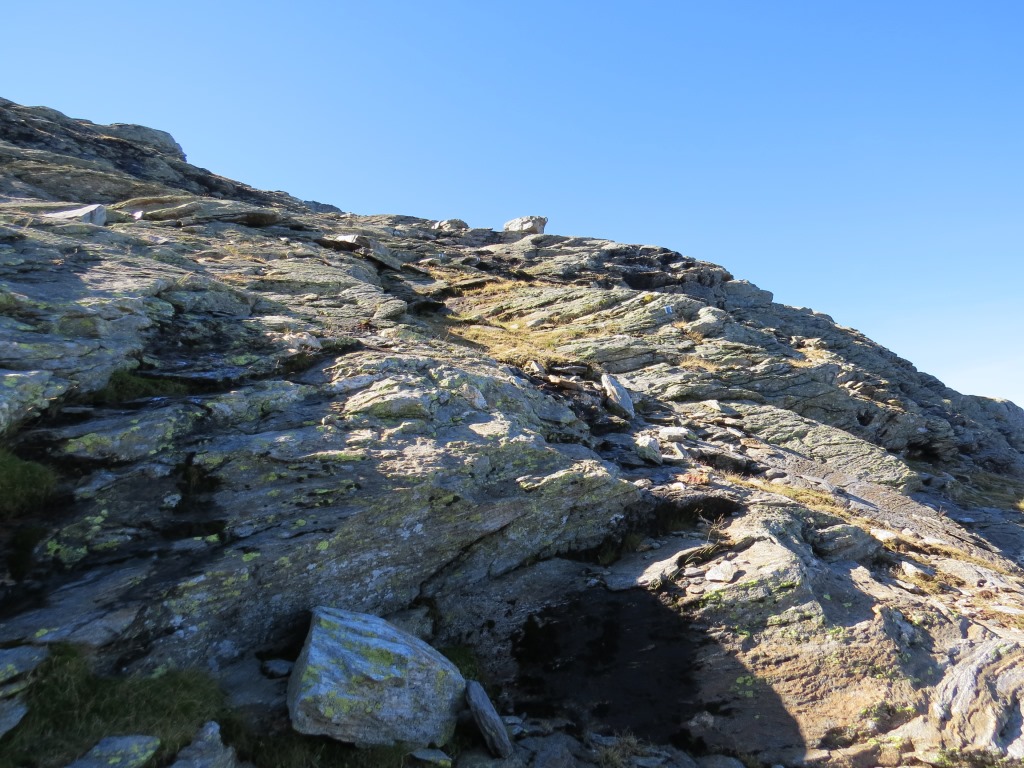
[0,0,1024,404]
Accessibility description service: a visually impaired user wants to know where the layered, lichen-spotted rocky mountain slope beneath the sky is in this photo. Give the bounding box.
[0,100,1024,768]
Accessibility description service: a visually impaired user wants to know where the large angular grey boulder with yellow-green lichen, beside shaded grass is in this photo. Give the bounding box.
[288,607,466,748]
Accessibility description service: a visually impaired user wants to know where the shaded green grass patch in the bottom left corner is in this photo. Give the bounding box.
[0,645,223,768]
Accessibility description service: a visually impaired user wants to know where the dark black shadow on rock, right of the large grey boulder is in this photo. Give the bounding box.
[512,589,805,757]
